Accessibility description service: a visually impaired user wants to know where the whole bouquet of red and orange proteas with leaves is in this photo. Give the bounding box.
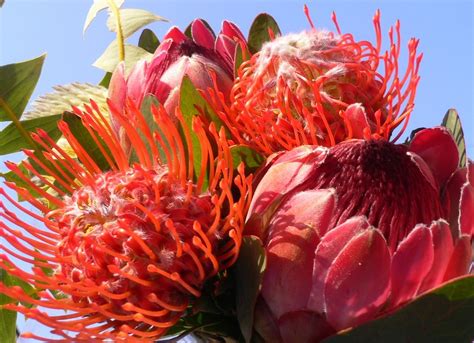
[0,0,474,343]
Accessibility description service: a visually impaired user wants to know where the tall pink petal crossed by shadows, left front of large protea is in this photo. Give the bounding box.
[262,189,335,318]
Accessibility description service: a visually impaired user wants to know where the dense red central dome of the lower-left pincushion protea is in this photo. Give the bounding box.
[53,166,216,327]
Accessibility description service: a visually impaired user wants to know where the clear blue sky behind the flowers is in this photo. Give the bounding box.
[0,0,474,340]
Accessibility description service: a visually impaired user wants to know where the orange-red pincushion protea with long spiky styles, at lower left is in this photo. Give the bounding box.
[0,101,250,342]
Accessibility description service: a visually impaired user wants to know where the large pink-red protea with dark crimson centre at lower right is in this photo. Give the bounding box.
[245,127,474,342]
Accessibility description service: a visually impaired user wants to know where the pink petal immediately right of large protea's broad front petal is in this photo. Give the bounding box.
[391,225,434,307]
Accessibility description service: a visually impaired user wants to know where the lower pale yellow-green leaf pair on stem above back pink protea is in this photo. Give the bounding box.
[92,40,153,73]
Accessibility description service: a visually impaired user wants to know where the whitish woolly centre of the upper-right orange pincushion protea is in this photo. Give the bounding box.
[248,30,383,117]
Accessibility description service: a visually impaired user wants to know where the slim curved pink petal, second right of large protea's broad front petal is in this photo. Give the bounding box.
[418,220,454,293]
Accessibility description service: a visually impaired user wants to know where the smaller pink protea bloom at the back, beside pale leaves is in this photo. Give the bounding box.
[109,19,247,117]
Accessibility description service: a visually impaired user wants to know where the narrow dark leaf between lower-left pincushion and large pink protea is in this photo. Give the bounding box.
[234,236,266,342]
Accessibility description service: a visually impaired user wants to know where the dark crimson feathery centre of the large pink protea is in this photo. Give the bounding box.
[310,139,443,251]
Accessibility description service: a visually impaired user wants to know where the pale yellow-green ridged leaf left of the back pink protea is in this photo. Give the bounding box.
[22,82,108,119]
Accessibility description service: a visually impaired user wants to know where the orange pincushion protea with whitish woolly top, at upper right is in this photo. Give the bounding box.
[216,8,421,156]
